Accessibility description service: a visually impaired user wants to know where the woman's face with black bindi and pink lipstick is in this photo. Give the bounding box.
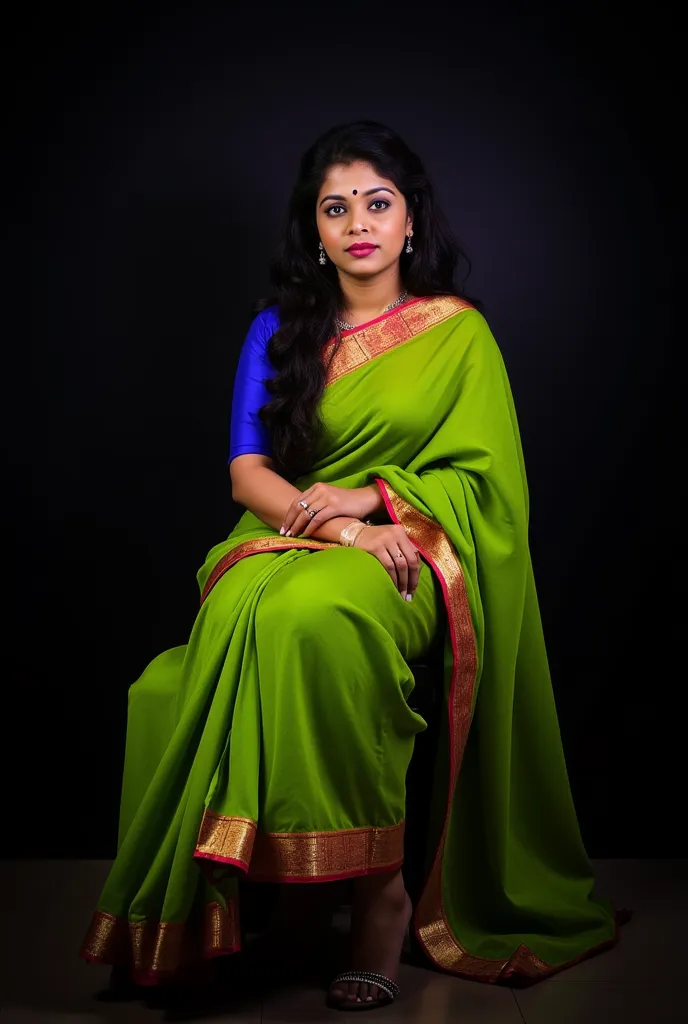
[316,162,413,278]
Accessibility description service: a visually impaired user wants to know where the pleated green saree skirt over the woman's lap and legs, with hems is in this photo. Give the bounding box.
[83,546,441,984]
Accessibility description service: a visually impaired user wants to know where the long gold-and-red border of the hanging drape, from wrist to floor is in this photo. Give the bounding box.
[376,478,628,984]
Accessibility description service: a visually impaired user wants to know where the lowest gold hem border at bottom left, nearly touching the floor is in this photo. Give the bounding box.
[80,900,242,985]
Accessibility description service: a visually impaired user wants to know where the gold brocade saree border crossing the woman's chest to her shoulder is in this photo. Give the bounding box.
[323,295,474,386]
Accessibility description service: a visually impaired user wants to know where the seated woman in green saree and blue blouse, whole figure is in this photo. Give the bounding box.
[82,122,617,1010]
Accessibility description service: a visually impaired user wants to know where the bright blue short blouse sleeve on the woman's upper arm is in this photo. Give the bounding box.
[228,309,280,462]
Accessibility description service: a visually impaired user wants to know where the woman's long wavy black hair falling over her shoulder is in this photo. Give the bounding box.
[256,121,475,479]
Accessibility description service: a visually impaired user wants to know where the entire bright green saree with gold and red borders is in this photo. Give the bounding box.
[82,296,617,983]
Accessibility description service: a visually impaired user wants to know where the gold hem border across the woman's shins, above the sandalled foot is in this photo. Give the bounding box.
[195,808,404,882]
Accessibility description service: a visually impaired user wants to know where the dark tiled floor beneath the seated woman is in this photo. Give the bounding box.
[0,860,688,1024]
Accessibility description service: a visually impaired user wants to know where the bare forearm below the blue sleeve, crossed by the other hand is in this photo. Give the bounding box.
[229,455,368,543]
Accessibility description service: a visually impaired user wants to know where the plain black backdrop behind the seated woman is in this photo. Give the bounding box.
[13,3,685,857]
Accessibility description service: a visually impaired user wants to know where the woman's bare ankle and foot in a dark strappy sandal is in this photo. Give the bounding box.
[330,870,413,1002]
